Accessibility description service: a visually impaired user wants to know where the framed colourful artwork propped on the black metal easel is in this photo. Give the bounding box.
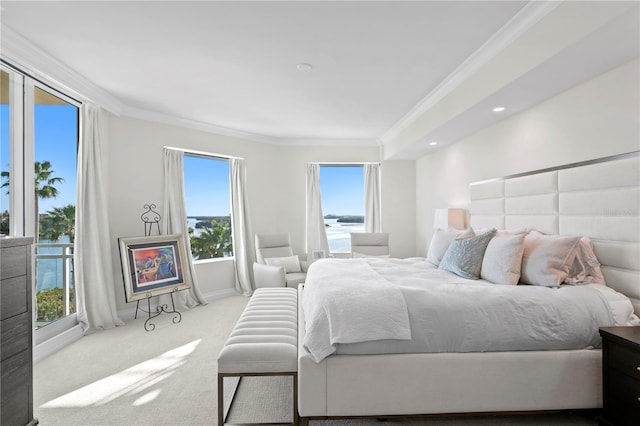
[118,234,191,303]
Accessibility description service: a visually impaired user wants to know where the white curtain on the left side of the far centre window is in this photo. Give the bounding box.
[307,163,329,258]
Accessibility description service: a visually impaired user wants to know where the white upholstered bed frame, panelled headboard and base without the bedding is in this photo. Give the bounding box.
[298,152,640,419]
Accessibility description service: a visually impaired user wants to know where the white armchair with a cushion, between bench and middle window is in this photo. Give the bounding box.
[253,234,309,288]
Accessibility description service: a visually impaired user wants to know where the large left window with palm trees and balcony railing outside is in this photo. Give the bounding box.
[0,67,79,328]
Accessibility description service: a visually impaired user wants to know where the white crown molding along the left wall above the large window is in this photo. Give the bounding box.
[1,25,124,115]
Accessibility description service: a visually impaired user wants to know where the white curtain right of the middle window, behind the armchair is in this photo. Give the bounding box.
[229,158,254,296]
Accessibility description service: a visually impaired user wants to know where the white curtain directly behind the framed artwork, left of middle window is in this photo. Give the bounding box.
[161,148,207,310]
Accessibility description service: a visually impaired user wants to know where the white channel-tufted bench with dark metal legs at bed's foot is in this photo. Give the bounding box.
[218,287,298,426]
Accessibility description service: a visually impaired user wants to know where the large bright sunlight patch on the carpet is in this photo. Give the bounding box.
[41,339,202,408]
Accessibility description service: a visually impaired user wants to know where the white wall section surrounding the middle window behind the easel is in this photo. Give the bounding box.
[107,117,278,311]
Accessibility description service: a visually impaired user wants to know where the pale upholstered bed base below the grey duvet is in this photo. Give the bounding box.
[298,287,602,417]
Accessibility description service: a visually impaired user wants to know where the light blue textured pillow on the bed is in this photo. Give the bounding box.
[438,229,496,280]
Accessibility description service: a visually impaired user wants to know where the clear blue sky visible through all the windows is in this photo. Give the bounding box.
[0,105,364,220]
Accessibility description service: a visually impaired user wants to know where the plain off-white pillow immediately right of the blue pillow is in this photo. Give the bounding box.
[480,231,524,285]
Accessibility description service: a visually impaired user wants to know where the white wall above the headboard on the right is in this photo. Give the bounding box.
[415,60,640,256]
